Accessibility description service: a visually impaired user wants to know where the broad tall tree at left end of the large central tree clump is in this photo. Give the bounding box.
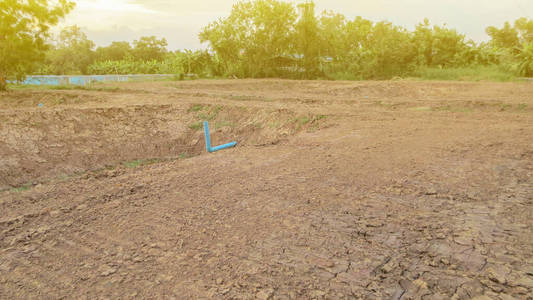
[200,0,296,77]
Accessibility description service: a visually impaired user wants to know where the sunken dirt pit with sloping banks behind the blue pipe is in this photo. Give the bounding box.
[0,91,326,189]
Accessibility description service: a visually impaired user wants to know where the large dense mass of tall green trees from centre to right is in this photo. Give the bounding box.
[196,0,533,80]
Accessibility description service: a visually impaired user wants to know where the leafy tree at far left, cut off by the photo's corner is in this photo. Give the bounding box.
[0,0,74,90]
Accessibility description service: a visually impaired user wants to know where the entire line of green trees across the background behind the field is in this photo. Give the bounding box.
[0,0,533,88]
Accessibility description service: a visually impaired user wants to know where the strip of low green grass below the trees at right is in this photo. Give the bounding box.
[413,66,517,82]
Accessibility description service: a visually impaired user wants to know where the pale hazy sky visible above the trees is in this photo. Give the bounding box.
[59,0,533,50]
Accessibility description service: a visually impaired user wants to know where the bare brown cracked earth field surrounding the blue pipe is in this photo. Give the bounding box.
[0,80,533,300]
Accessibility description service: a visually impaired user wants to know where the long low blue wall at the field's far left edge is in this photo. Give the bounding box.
[8,74,174,85]
